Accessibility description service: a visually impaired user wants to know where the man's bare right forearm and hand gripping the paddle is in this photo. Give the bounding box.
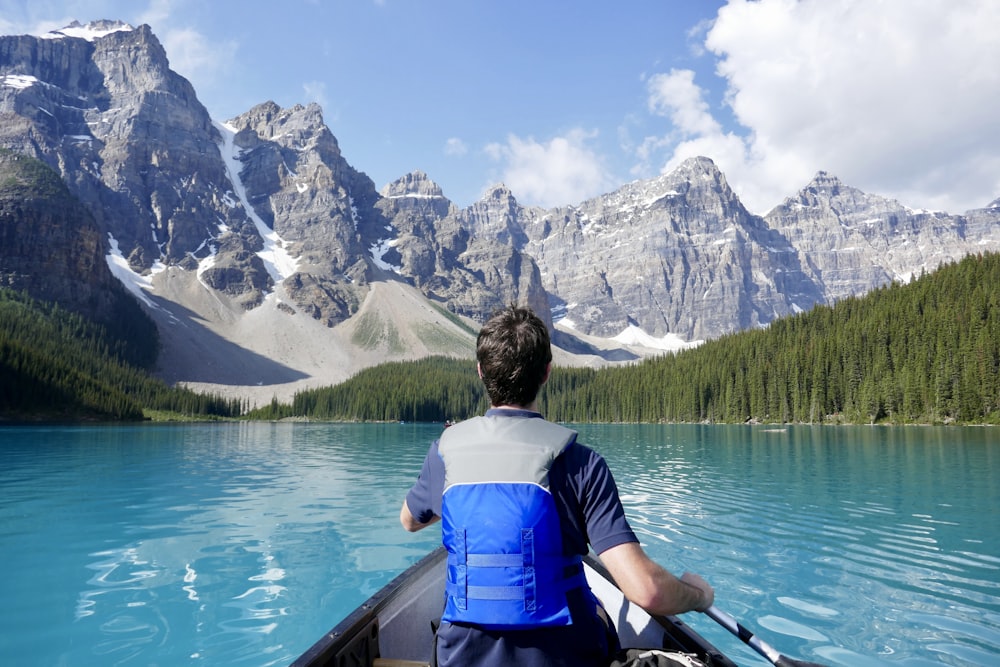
[596,544,715,615]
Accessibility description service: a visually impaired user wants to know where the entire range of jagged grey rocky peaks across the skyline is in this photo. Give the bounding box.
[0,22,1000,376]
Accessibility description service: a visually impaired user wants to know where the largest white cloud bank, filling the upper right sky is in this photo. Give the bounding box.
[637,0,1000,213]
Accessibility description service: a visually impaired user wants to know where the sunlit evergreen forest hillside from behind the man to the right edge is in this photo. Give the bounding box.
[255,254,1000,424]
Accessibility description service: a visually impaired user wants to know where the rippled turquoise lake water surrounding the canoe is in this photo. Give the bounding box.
[0,423,1000,667]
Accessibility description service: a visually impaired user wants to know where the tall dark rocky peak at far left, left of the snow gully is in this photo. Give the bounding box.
[0,23,230,271]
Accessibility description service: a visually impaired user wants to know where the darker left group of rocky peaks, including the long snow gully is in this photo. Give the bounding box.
[0,22,547,334]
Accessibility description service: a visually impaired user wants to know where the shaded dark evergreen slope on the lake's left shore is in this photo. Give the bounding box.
[0,289,242,420]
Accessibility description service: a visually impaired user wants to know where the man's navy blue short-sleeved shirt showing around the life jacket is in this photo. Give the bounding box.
[406,409,638,667]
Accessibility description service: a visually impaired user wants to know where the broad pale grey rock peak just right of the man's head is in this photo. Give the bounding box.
[525,158,823,339]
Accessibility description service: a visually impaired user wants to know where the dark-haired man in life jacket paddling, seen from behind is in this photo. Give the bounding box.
[399,305,715,667]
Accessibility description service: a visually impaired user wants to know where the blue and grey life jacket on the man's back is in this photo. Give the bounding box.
[438,416,586,630]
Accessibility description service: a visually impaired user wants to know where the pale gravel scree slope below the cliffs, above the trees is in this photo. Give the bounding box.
[150,269,653,407]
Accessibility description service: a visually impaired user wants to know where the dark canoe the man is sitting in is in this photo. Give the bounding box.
[292,547,736,667]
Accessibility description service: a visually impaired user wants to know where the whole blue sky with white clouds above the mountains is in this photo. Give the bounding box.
[0,0,1000,214]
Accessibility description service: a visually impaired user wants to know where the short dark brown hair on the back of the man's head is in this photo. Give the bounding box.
[476,304,552,406]
